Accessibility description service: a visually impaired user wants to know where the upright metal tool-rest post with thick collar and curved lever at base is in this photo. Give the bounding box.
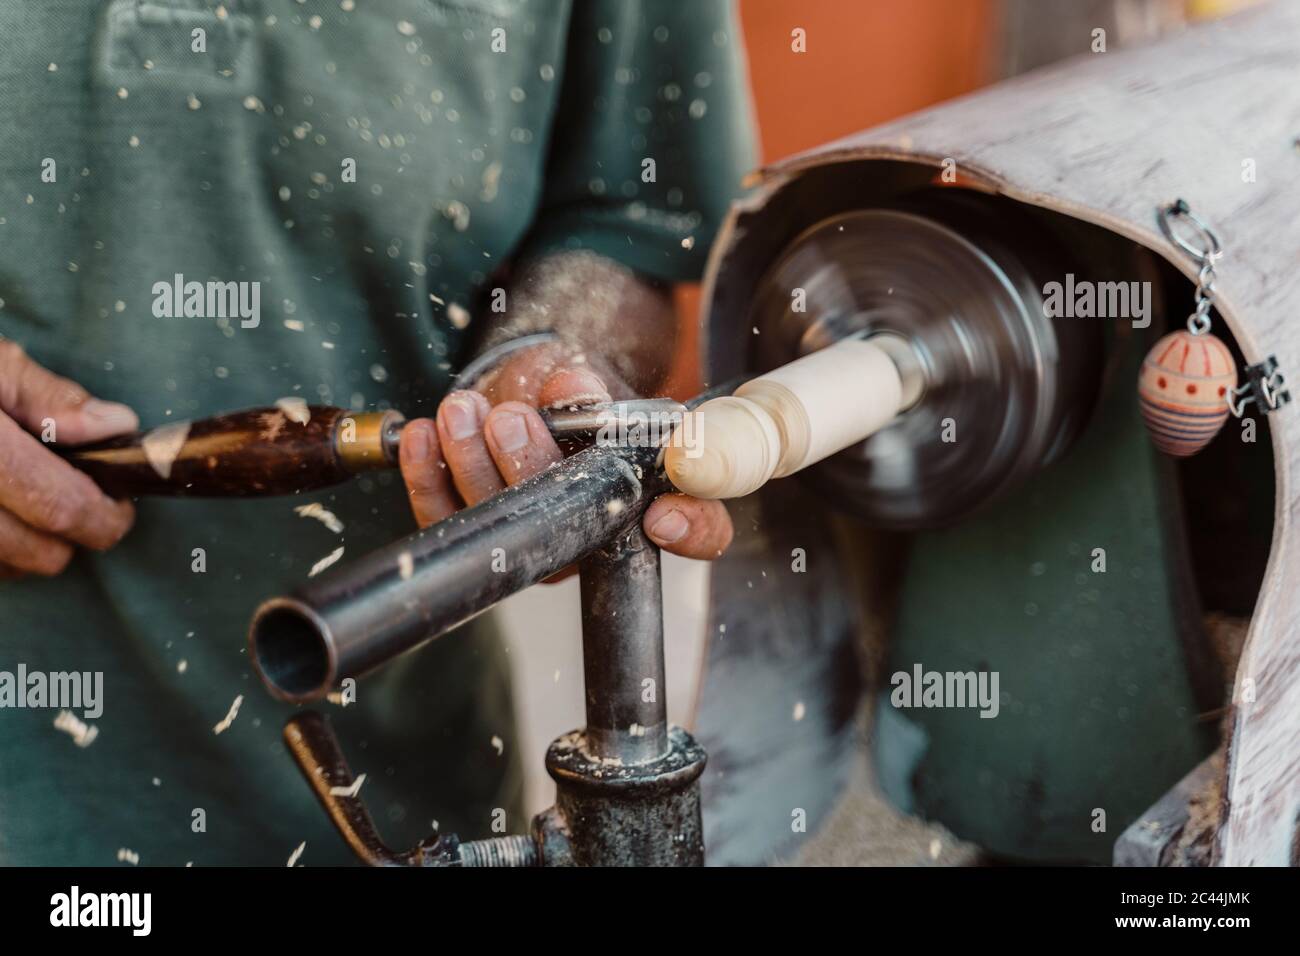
[285,447,706,866]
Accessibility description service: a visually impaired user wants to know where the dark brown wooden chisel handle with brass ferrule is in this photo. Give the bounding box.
[59,402,404,498]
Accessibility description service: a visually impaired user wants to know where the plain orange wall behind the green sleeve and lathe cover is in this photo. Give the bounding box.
[667,0,996,398]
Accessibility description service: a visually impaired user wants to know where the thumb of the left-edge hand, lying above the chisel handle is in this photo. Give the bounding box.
[0,341,140,445]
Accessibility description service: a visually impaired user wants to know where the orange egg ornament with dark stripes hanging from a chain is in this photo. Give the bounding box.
[1138,329,1236,458]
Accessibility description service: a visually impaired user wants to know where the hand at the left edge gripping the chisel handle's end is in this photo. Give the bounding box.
[0,341,139,578]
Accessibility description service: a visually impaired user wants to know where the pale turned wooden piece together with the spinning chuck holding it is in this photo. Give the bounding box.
[664,200,1100,529]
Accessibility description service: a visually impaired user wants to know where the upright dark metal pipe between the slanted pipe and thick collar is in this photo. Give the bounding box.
[579,522,668,765]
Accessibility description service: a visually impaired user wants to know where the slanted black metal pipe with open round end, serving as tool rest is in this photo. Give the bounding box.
[248,446,670,701]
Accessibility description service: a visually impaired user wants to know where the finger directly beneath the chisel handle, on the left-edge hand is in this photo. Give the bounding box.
[0,415,135,550]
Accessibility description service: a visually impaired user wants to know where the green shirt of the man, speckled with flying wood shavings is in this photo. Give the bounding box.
[0,0,751,865]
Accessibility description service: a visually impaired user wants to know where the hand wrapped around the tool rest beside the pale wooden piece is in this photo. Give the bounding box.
[400,343,732,559]
